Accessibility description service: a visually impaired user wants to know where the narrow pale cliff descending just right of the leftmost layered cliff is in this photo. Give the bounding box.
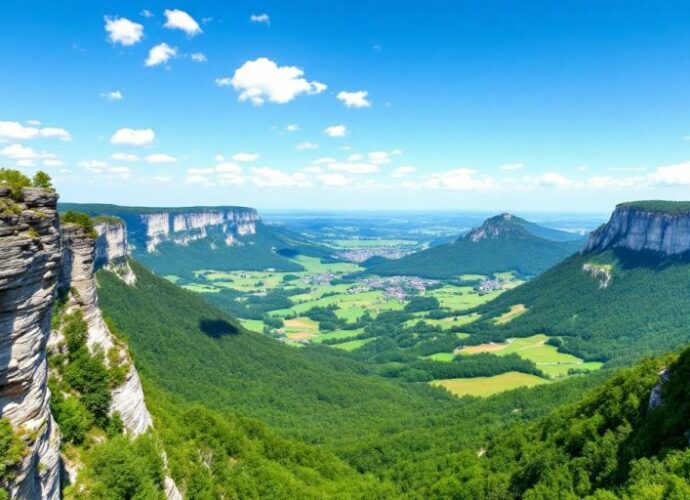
[60,225,151,436]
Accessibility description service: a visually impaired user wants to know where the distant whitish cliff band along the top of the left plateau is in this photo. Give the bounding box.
[137,207,260,253]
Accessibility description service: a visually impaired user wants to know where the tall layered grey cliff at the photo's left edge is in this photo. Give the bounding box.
[0,188,62,499]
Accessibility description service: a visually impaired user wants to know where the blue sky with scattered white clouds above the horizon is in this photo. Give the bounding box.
[0,0,690,211]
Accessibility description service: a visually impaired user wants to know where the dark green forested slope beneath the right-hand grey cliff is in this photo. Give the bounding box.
[465,251,690,365]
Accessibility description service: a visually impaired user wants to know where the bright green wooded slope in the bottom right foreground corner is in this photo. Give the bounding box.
[446,350,690,499]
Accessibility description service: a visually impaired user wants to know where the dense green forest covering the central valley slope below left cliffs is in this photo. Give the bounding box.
[98,263,607,498]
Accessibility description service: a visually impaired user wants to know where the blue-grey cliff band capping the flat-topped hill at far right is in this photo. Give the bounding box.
[583,204,690,256]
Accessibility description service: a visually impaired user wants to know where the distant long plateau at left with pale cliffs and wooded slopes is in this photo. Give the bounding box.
[59,203,332,278]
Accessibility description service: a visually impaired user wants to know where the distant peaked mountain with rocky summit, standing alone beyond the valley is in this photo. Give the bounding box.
[368,213,583,278]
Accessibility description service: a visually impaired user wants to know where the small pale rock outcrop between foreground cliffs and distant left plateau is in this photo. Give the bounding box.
[94,218,137,285]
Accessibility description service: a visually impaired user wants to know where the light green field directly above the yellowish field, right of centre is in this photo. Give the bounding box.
[459,334,603,378]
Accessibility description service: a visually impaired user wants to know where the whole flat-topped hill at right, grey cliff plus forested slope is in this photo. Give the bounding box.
[467,201,690,364]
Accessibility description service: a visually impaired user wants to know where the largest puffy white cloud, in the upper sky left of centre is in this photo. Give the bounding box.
[228,57,326,106]
